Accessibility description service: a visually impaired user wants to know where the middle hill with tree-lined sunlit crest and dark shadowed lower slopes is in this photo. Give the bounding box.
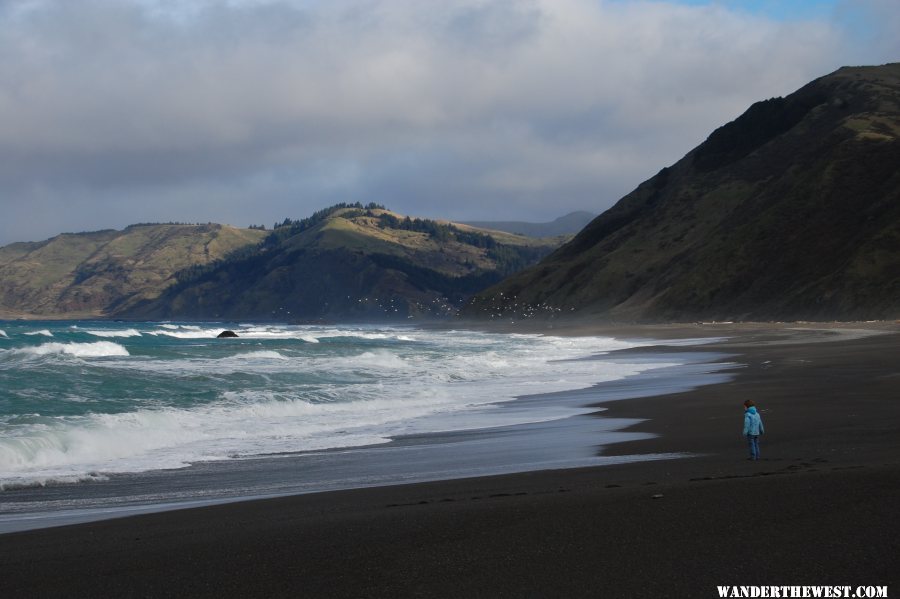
[117,205,564,321]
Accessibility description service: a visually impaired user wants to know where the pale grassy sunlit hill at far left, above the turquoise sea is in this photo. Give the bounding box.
[0,224,266,318]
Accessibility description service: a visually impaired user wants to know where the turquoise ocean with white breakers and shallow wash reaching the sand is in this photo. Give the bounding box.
[0,321,727,532]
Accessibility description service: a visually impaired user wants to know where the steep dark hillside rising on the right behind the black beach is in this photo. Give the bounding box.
[464,64,900,322]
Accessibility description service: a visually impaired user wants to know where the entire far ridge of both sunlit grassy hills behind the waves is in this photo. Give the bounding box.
[0,204,571,320]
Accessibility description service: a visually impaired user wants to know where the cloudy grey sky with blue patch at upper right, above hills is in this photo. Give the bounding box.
[0,0,900,245]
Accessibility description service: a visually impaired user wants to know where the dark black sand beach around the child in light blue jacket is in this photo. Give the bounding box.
[0,324,900,597]
